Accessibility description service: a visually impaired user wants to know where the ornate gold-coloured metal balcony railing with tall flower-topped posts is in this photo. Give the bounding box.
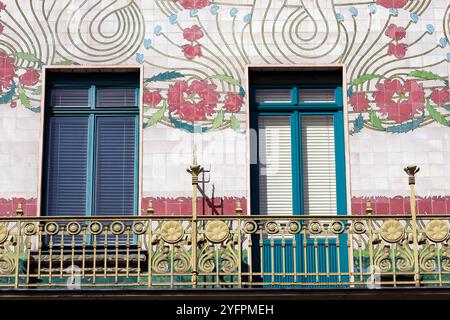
[0,165,450,290]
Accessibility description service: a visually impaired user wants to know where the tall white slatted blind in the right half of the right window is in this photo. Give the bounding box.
[301,116,337,215]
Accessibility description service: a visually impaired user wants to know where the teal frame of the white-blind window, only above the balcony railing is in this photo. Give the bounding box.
[250,85,347,215]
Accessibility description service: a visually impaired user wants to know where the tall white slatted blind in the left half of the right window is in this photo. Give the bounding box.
[258,116,292,215]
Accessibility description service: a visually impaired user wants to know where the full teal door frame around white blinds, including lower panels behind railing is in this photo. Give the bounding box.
[250,84,349,288]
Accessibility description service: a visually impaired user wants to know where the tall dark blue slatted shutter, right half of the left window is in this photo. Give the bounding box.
[94,116,136,215]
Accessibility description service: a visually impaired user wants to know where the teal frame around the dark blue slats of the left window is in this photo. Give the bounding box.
[41,79,140,217]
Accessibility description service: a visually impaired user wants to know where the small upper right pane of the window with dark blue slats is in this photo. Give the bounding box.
[97,88,137,107]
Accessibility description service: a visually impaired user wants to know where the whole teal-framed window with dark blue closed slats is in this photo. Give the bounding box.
[41,72,139,216]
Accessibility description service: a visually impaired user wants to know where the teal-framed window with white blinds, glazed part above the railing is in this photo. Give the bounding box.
[251,85,346,215]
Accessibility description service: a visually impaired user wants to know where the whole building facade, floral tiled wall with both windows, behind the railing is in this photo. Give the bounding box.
[0,0,450,290]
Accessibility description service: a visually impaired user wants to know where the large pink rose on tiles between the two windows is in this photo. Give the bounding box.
[167,80,220,122]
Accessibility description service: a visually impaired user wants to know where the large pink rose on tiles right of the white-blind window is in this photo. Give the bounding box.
[373,79,425,123]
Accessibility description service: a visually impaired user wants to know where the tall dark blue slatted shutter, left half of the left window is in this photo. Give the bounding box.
[44,117,88,215]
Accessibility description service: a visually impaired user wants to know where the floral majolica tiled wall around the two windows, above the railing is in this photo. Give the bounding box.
[0,0,450,215]
